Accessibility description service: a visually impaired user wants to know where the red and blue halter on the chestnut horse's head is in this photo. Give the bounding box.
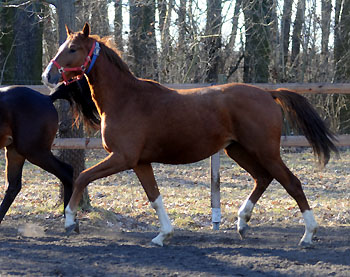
[51,41,101,85]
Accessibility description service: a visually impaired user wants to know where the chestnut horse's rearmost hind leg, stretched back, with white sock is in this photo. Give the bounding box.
[260,152,318,246]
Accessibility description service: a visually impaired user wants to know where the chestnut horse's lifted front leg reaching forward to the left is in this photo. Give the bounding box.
[65,153,131,233]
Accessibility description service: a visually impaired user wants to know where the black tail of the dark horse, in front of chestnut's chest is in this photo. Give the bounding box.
[50,77,101,129]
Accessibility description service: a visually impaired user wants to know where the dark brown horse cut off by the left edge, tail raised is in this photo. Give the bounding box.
[0,75,99,222]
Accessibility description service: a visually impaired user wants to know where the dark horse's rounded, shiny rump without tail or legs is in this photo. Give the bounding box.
[0,86,58,154]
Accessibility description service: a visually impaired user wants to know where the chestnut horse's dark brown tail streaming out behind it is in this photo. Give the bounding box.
[269,89,338,166]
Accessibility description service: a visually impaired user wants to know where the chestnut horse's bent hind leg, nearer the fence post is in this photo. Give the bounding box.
[225,143,273,239]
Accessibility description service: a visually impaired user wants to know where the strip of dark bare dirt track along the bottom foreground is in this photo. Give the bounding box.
[0,220,350,276]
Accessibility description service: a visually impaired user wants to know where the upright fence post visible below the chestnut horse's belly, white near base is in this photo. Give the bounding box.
[210,152,221,230]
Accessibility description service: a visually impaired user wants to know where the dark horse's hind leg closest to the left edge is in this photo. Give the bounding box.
[0,146,25,223]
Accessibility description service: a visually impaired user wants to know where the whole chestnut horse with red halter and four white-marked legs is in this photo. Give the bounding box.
[42,24,336,246]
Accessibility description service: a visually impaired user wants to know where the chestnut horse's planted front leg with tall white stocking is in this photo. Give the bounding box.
[134,164,174,246]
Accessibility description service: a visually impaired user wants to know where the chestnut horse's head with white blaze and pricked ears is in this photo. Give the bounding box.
[42,23,99,87]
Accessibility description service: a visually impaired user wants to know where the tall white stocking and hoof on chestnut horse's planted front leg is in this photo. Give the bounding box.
[151,195,174,246]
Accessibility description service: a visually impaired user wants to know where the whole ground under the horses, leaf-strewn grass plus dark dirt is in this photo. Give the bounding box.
[0,152,350,276]
